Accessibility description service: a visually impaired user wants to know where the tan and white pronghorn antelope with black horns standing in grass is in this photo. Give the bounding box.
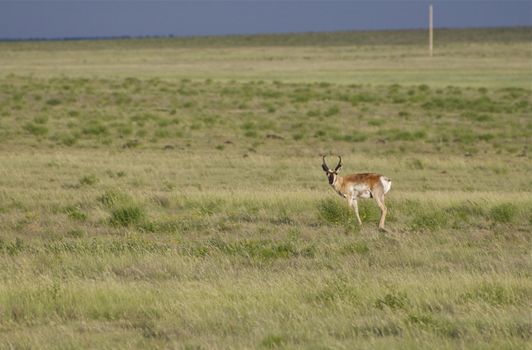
[321,156,392,230]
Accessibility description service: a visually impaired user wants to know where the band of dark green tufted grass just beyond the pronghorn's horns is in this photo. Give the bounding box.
[0,76,532,156]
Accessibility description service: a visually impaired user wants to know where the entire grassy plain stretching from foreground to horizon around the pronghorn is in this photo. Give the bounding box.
[0,28,532,349]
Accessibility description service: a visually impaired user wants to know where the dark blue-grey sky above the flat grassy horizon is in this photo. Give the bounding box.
[0,0,532,39]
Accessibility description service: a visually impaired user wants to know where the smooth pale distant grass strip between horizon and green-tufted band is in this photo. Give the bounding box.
[0,27,532,87]
